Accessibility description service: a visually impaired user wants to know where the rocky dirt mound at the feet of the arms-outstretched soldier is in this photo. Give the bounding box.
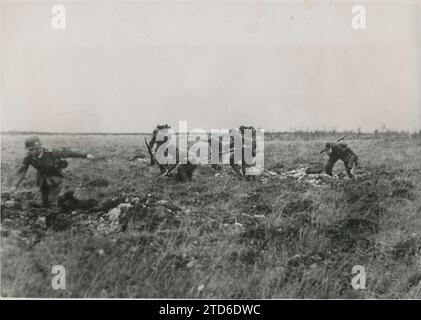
[1,191,181,242]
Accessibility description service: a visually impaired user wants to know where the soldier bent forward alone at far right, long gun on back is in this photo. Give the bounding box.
[325,142,358,178]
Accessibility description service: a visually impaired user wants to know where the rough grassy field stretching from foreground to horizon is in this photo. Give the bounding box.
[1,134,421,299]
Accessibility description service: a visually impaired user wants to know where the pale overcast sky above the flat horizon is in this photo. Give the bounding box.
[0,0,421,132]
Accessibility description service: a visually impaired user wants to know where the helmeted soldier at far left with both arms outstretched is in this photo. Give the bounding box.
[10,136,94,227]
